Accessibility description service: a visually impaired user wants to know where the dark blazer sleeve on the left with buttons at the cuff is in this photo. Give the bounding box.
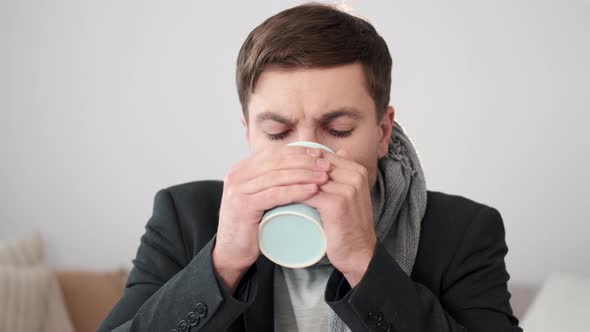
[98,189,257,332]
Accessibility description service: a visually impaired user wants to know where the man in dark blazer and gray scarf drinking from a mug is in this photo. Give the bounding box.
[99,4,520,332]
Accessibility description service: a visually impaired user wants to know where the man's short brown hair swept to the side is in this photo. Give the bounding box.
[236,3,392,121]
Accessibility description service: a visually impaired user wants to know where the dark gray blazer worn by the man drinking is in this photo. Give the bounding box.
[99,181,522,332]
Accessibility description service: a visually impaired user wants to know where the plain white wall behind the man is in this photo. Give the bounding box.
[0,0,590,282]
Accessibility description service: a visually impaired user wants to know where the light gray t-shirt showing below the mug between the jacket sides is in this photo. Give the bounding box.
[274,265,334,332]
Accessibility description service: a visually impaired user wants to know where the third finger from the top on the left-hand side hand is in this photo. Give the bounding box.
[240,169,328,195]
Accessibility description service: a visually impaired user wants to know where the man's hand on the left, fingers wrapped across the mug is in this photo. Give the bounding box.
[212,146,330,293]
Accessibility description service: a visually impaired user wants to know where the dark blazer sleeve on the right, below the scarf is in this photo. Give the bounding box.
[325,207,522,332]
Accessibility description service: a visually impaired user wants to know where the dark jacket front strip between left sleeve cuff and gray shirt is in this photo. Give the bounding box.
[244,253,275,332]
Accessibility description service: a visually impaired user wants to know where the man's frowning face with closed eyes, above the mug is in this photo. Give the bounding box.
[242,63,394,187]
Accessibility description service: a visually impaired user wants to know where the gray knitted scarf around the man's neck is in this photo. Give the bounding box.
[316,121,426,332]
